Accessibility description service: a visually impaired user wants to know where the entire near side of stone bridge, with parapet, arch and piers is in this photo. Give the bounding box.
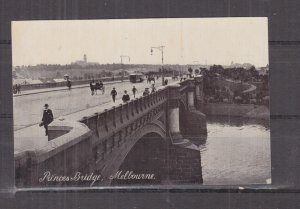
[15,77,206,186]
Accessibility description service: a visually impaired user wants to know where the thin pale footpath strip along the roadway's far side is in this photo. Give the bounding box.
[13,80,129,97]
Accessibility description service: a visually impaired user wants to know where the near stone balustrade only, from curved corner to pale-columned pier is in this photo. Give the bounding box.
[79,88,168,147]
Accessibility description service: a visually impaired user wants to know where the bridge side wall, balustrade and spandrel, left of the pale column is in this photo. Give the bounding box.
[80,88,167,185]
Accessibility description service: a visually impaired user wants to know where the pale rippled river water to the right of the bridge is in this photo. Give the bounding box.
[200,116,271,185]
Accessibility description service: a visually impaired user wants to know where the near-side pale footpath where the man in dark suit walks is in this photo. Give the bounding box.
[14,82,174,154]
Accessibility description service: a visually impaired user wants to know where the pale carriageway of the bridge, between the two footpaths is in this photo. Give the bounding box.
[13,79,171,131]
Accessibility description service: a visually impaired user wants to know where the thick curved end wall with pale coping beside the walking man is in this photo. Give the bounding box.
[15,121,93,187]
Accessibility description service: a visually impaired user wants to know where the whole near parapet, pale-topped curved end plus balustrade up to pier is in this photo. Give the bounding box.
[15,77,199,185]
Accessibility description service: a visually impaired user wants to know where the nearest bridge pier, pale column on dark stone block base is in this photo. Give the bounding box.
[167,85,203,184]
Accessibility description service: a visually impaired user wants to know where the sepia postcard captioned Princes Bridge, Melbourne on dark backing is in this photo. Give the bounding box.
[11,17,271,188]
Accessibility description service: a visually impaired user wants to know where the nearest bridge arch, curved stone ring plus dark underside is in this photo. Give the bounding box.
[102,120,167,185]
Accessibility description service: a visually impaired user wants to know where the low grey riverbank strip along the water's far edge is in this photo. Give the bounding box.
[203,103,270,120]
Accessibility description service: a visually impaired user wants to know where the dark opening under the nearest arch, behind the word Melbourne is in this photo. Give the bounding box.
[111,132,168,185]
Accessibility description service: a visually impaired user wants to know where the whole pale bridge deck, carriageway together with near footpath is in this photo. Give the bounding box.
[13,78,173,152]
